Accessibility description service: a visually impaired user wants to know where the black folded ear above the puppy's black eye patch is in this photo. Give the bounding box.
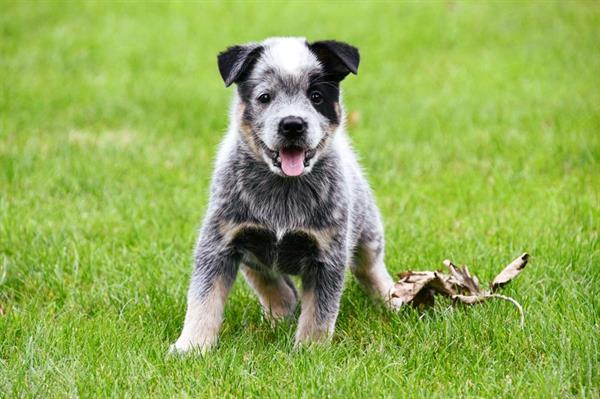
[308,40,360,80]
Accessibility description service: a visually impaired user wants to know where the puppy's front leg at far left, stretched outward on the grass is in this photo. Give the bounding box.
[171,231,237,353]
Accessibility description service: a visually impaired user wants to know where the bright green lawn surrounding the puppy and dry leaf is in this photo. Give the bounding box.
[0,1,600,398]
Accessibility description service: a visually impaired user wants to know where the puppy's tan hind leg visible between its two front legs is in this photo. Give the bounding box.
[241,265,298,321]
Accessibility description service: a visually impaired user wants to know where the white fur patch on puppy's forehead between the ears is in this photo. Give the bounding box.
[262,37,319,73]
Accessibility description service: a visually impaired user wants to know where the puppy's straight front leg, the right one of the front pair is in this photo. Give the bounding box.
[296,259,345,345]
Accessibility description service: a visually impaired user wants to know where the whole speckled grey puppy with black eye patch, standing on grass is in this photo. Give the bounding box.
[172,38,400,353]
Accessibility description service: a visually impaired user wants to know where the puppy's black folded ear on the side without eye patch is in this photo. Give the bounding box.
[217,44,263,87]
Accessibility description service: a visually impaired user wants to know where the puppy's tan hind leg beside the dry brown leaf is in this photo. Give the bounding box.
[350,222,402,309]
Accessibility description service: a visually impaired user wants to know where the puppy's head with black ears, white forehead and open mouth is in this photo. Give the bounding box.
[218,38,360,176]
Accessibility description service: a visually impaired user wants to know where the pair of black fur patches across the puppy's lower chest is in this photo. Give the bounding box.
[230,224,329,274]
